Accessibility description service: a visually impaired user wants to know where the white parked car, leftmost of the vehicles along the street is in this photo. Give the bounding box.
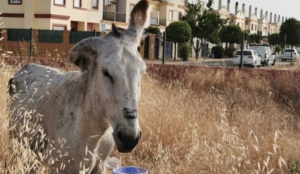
[232,50,261,67]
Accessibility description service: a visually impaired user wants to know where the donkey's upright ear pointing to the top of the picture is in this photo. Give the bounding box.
[128,0,152,43]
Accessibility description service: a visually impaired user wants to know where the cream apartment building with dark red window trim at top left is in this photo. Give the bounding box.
[0,0,103,31]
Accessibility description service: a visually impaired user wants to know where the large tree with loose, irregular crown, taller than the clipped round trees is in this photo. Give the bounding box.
[181,0,227,59]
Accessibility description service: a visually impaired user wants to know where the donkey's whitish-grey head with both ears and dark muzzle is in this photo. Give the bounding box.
[69,0,149,152]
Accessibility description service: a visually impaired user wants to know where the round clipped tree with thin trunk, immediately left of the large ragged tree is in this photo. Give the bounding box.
[166,21,192,61]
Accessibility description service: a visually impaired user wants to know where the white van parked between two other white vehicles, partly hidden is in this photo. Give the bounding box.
[249,45,276,66]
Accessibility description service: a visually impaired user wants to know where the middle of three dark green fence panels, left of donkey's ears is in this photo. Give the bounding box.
[38,30,63,43]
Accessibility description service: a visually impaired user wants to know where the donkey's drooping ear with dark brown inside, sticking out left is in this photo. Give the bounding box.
[69,38,99,71]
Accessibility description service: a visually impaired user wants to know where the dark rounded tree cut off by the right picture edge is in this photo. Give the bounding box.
[279,18,300,47]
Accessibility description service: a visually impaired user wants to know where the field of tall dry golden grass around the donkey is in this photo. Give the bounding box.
[0,57,300,174]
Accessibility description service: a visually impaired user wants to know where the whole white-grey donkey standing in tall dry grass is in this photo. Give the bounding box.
[9,0,149,174]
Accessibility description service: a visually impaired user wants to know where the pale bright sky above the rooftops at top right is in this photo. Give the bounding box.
[189,0,300,20]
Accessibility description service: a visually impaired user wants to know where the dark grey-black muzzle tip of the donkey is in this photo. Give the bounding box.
[114,131,142,153]
